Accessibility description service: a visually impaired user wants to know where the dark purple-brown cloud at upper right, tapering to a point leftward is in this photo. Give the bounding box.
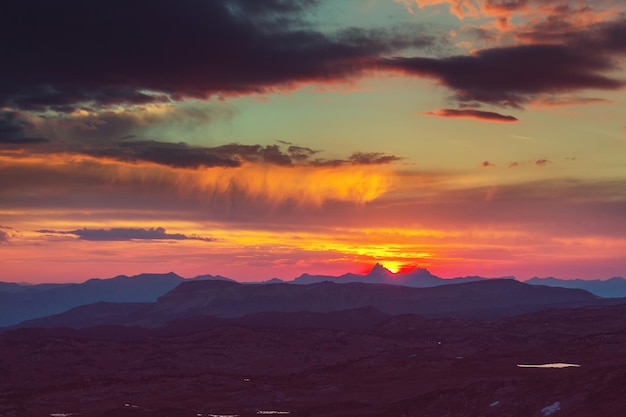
[381,20,626,107]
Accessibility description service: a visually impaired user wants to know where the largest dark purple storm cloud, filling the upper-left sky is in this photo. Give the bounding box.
[0,0,431,111]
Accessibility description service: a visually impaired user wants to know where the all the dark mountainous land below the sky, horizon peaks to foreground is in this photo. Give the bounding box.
[0,265,626,417]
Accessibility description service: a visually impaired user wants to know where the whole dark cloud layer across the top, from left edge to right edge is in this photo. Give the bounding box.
[0,0,626,118]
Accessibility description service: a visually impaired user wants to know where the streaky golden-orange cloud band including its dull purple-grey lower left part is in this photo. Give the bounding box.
[0,154,394,210]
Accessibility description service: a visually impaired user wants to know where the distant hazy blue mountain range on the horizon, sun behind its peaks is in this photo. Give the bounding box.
[0,264,626,326]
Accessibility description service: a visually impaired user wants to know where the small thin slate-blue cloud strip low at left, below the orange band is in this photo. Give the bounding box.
[36,227,216,242]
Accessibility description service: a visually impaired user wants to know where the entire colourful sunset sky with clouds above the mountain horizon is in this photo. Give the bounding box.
[0,0,626,283]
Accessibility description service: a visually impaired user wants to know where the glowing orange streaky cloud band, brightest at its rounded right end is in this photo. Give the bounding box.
[0,153,393,206]
